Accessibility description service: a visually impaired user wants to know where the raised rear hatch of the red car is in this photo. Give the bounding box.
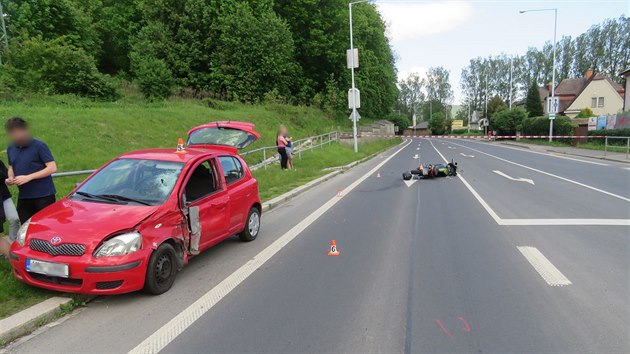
[187,122,260,149]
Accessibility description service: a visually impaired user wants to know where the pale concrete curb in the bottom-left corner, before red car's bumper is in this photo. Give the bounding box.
[0,296,73,342]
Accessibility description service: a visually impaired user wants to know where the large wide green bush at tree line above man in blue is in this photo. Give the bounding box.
[9,37,120,101]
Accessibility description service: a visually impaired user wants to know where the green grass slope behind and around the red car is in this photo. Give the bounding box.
[0,97,399,318]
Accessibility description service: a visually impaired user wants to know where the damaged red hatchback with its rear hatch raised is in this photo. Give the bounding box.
[10,122,262,294]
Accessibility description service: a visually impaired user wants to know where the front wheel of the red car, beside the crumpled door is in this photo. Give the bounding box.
[144,243,177,295]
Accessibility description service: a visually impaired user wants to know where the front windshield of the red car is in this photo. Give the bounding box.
[72,159,184,205]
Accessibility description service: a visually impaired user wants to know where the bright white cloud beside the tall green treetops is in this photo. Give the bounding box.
[377,1,473,41]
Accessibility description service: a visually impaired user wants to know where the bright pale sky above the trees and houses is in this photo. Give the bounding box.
[378,0,630,104]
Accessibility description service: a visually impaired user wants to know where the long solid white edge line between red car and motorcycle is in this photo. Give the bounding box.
[129,140,411,354]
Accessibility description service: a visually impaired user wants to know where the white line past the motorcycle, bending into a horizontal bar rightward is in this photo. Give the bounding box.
[429,140,630,226]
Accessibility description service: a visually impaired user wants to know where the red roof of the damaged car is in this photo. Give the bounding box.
[118,146,236,163]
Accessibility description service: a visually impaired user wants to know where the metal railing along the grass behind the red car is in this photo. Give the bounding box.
[52,131,341,177]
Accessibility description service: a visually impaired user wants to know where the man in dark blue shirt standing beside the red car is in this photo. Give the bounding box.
[5,117,57,223]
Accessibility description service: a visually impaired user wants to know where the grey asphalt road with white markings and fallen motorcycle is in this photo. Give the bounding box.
[9,139,630,353]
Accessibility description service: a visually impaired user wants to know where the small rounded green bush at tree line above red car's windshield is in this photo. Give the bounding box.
[132,57,175,100]
